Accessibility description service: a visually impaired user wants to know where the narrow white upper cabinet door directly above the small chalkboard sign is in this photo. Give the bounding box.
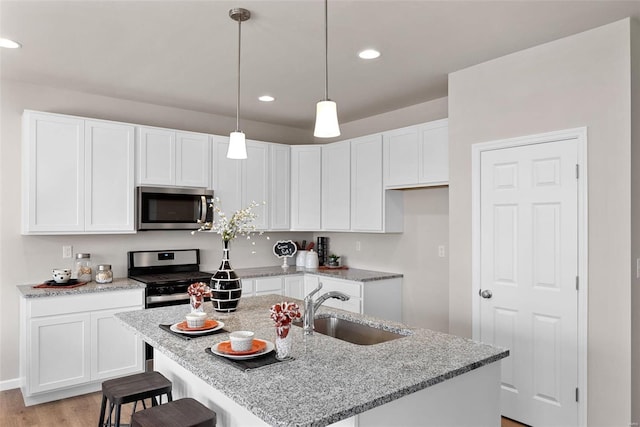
[267,144,291,230]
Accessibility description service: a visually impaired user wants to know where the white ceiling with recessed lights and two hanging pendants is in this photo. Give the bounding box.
[0,0,640,129]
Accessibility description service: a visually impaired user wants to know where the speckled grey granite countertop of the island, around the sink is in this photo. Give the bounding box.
[116,295,509,426]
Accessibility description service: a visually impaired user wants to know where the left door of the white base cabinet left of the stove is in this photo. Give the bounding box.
[27,313,91,394]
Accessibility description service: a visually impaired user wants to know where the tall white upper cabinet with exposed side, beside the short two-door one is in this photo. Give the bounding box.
[351,134,403,233]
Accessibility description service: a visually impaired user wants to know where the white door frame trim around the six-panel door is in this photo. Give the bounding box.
[471,127,589,426]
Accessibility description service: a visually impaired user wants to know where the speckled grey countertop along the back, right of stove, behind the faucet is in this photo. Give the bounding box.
[235,266,402,282]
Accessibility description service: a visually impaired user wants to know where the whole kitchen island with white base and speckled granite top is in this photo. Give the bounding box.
[116,295,508,427]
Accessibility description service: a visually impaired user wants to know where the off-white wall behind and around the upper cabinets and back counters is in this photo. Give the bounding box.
[0,80,448,389]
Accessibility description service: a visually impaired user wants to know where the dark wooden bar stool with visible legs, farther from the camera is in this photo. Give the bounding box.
[98,371,173,427]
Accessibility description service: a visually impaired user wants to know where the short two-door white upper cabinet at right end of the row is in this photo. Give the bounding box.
[383,119,449,188]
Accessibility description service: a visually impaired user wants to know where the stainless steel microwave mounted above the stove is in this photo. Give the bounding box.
[136,187,213,230]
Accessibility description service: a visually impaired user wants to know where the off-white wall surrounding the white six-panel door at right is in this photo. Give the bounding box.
[449,20,640,426]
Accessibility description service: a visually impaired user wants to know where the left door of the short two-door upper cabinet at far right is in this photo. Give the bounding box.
[384,126,420,187]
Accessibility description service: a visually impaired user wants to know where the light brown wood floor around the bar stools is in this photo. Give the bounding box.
[0,389,525,427]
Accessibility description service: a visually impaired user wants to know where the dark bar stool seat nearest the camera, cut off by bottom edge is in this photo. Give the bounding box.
[131,397,216,427]
